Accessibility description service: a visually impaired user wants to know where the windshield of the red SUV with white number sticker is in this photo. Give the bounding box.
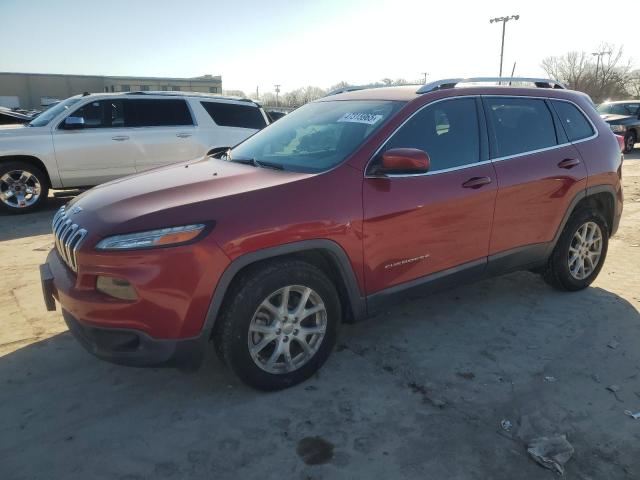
[231,100,404,172]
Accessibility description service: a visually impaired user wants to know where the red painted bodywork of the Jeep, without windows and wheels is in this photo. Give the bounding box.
[43,87,622,366]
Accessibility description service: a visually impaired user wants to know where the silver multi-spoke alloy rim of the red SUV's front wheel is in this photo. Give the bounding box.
[248,285,327,374]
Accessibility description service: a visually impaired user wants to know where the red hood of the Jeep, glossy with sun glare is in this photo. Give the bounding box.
[67,157,314,234]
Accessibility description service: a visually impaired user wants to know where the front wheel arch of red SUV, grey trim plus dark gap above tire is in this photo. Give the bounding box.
[202,239,366,333]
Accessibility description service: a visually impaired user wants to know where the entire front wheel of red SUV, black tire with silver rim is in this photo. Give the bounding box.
[214,260,342,390]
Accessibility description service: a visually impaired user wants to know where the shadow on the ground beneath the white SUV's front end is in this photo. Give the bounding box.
[0,190,79,242]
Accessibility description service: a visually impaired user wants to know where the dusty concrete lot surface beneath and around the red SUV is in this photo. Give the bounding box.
[0,153,640,480]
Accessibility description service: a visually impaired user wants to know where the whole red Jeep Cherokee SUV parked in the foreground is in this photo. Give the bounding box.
[41,78,622,389]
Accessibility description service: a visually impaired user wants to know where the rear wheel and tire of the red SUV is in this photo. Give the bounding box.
[543,209,609,291]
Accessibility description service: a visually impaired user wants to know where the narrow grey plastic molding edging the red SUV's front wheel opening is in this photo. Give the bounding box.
[202,239,367,332]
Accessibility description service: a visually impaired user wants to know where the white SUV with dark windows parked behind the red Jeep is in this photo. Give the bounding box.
[0,92,269,213]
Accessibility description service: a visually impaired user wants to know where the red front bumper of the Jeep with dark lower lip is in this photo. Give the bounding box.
[40,240,228,369]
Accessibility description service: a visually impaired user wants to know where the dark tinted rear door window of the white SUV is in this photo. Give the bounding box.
[124,99,193,127]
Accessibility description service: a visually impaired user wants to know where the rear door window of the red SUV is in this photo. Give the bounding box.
[486,97,558,158]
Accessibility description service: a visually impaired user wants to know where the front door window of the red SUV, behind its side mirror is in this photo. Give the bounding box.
[385,98,480,172]
